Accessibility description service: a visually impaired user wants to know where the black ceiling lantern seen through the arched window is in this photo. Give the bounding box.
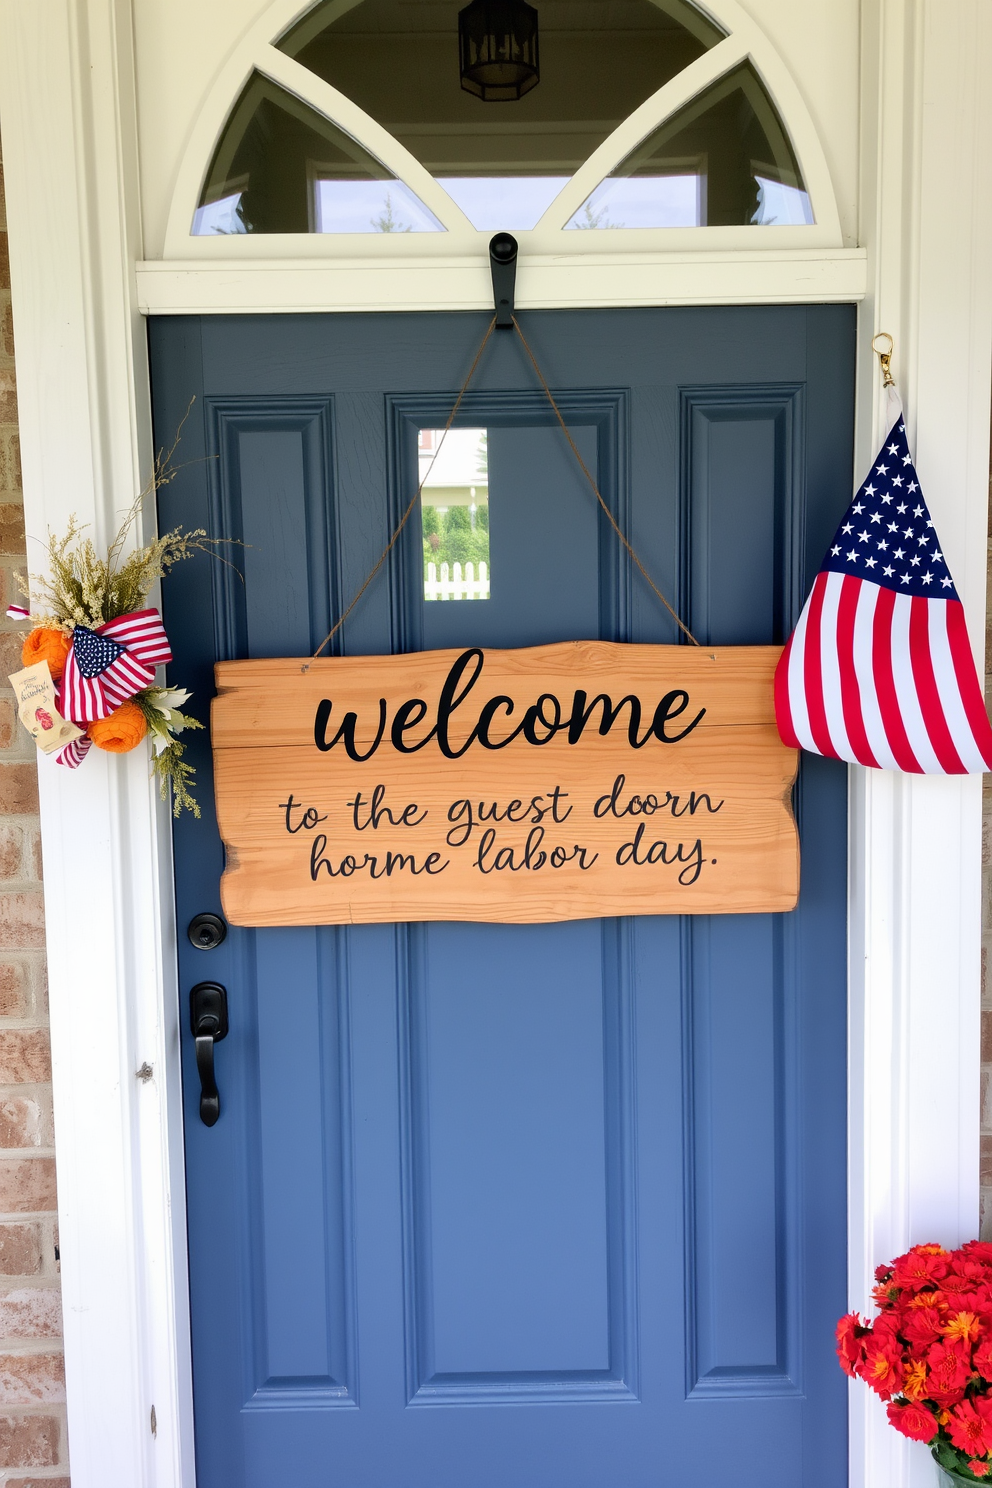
[458,0,541,103]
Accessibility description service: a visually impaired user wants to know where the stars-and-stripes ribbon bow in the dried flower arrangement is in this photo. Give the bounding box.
[59,610,173,726]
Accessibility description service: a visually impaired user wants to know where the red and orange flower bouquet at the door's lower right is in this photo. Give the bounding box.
[837,1240,992,1488]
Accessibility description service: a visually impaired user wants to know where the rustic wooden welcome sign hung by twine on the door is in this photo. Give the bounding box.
[211,641,799,926]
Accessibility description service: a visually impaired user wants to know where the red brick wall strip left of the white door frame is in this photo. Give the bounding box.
[0,142,68,1488]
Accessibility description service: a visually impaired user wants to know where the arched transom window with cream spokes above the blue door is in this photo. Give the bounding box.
[187,0,833,250]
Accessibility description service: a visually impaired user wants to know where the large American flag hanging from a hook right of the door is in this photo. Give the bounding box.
[775,411,992,775]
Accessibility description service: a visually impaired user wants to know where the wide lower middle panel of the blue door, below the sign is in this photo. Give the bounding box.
[403,921,634,1405]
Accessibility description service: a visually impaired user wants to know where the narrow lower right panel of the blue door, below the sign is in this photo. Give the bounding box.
[689,915,797,1396]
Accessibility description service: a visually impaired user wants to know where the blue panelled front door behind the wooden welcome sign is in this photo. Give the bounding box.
[152,307,854,1488]
